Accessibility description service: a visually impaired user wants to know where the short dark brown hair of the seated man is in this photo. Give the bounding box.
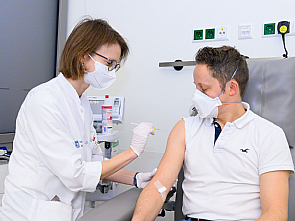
[195,46,249,97]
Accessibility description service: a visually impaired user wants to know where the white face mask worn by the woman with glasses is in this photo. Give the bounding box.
[84,55,116,90]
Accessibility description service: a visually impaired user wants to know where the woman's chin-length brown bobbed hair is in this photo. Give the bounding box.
[58,18,129,80]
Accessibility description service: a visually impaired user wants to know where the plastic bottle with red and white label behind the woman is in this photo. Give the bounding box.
[101,94,113,134]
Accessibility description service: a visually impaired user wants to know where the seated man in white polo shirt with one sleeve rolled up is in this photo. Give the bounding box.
[132,46,294,221]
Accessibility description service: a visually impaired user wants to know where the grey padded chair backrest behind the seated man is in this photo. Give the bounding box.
[174,57,295,221]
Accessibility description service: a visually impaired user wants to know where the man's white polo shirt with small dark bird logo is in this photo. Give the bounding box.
[182,102,294,220]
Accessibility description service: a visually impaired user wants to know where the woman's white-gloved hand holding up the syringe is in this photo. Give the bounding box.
[130,122,155,156]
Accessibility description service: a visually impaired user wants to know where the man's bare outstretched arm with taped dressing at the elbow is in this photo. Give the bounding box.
[132,120,185,221]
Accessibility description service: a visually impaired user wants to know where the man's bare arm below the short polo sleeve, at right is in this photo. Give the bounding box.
[260,170,290,217]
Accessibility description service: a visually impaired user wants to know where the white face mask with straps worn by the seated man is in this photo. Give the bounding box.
[192,68,241,118]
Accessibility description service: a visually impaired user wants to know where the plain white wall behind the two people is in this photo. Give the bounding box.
[68,0,295,218]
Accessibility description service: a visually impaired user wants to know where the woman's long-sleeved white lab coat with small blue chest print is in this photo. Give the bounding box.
[2,74,102,221]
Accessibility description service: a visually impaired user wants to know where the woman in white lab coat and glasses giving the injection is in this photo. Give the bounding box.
[2,19,155,221]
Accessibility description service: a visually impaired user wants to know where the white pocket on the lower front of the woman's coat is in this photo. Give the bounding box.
[36,200,73,221]
